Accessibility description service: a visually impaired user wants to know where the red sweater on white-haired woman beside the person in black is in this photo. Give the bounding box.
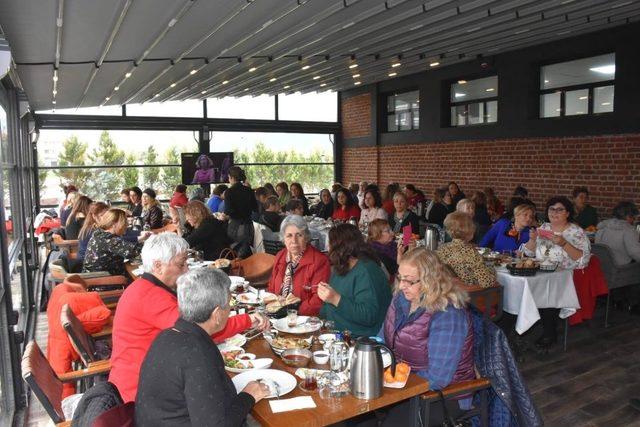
[109,273,251,403]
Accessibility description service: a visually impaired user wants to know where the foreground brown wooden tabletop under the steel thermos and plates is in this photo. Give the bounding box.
[236,337,429,427]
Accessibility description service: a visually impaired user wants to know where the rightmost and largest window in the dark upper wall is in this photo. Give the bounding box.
[540,53,616,118]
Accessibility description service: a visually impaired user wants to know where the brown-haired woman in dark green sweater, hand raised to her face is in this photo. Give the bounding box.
[318,224,391,336]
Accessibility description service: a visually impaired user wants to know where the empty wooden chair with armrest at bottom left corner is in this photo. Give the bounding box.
[22,341,111,426]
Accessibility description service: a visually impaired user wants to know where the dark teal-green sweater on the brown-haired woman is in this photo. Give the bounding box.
[320,260,391,336]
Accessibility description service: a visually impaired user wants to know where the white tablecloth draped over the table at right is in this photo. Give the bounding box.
[496,268,580,334]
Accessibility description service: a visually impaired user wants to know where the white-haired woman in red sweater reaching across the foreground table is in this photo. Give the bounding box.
[109,233,269,402]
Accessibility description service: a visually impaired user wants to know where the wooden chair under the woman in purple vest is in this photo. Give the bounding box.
[420,378,491,427]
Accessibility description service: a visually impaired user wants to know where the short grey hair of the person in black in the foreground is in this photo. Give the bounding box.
[178,268,231,323]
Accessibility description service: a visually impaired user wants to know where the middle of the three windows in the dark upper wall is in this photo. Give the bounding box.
[449,76,498,126]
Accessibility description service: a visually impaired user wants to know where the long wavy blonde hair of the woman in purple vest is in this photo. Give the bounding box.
[394,247,469,312]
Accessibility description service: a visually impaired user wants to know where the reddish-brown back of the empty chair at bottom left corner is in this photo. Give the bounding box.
[22,341,65,424]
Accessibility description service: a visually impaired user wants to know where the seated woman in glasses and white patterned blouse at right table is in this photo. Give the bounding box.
[521,196,591,348]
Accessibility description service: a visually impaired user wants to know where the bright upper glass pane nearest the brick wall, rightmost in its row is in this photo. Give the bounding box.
[278,91,338,122]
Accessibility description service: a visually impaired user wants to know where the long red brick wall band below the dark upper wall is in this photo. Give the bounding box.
[342,134,640,216]
